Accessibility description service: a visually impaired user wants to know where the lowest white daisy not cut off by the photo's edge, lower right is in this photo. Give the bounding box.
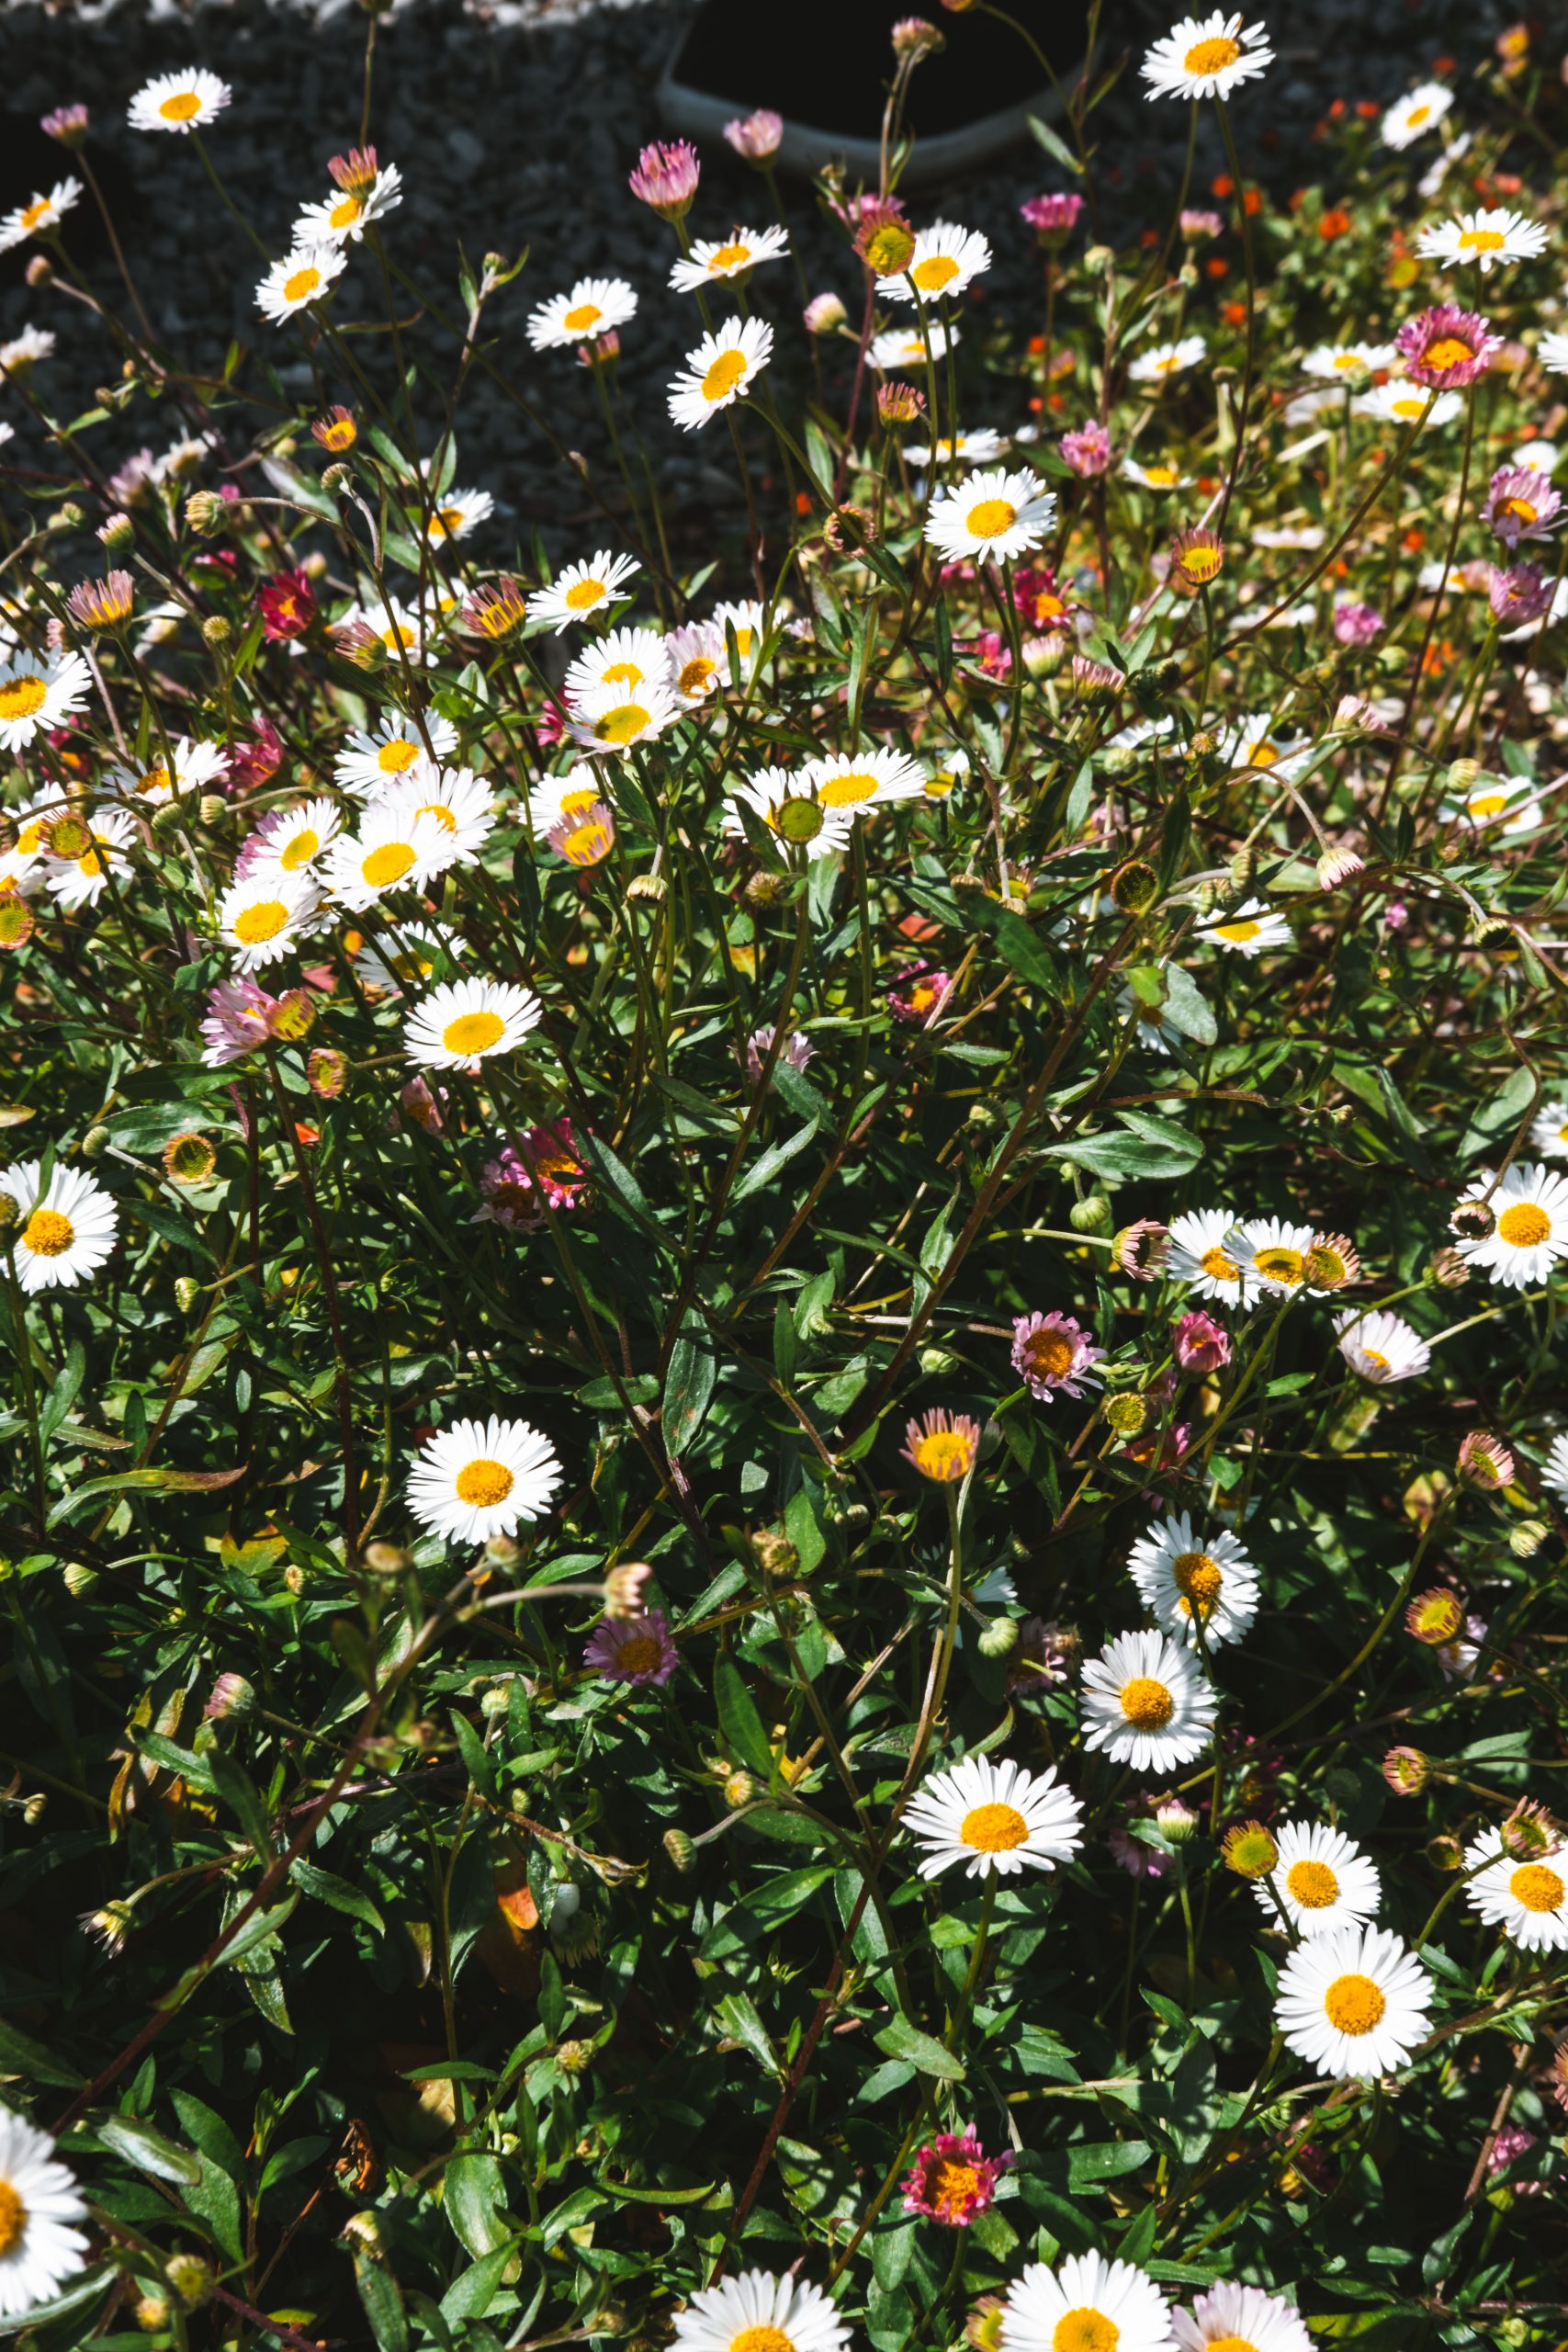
[1274,1927,1432,2079]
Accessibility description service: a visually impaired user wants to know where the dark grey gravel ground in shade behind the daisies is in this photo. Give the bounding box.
[0,0,1528,562]
